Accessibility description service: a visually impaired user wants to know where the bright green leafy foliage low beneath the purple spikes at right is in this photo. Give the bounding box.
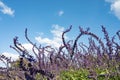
[59,68,120,80]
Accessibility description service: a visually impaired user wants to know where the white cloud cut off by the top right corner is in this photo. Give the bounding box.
[105,0,120,19]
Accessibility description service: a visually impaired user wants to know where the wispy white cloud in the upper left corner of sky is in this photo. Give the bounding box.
[0,1,15,16]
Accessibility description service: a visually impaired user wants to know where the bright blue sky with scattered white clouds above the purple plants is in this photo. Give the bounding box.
[0,0,120,64]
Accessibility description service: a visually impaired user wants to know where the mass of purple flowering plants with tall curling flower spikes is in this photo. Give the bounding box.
[0,26,120,80]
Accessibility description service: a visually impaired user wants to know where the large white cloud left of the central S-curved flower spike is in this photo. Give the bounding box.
[35,24,64,48]
